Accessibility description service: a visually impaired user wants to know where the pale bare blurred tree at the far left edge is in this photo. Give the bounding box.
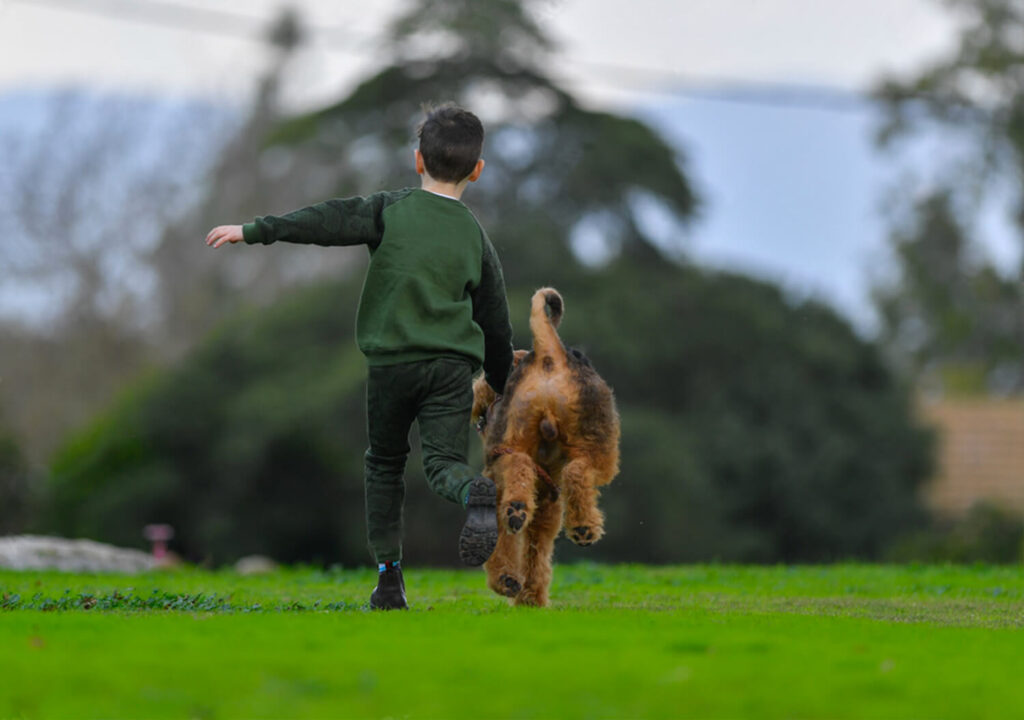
[0,90,223,465]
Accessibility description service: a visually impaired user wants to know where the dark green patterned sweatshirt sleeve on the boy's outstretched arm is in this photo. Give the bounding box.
[242,193,388,248]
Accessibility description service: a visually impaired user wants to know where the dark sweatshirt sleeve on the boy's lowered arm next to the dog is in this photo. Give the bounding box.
[472,228,512,394]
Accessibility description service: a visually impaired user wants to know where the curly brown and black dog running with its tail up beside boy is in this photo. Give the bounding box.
[473,288,620,605]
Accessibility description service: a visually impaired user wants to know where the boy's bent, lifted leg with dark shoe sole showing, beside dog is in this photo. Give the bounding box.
[418,358,498,565]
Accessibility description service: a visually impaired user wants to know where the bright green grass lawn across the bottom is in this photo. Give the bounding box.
[0,565,1024,719]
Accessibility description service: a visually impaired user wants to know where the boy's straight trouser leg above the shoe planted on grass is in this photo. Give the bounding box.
[366,366,416,563]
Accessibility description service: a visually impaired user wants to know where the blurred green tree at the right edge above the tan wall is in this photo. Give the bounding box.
[877,0,1024,393]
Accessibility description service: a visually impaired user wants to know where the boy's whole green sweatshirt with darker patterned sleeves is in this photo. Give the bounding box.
[243,188,512,392]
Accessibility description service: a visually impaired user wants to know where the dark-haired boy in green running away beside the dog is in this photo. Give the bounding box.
[206,104,512,609]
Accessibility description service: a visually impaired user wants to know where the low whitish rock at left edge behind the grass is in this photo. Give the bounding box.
[0,535,155,573]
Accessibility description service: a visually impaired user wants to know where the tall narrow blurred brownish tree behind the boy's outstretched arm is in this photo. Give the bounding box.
[151,7,329,359]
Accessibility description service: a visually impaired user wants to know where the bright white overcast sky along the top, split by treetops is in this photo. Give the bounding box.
[0,0,953,104]
